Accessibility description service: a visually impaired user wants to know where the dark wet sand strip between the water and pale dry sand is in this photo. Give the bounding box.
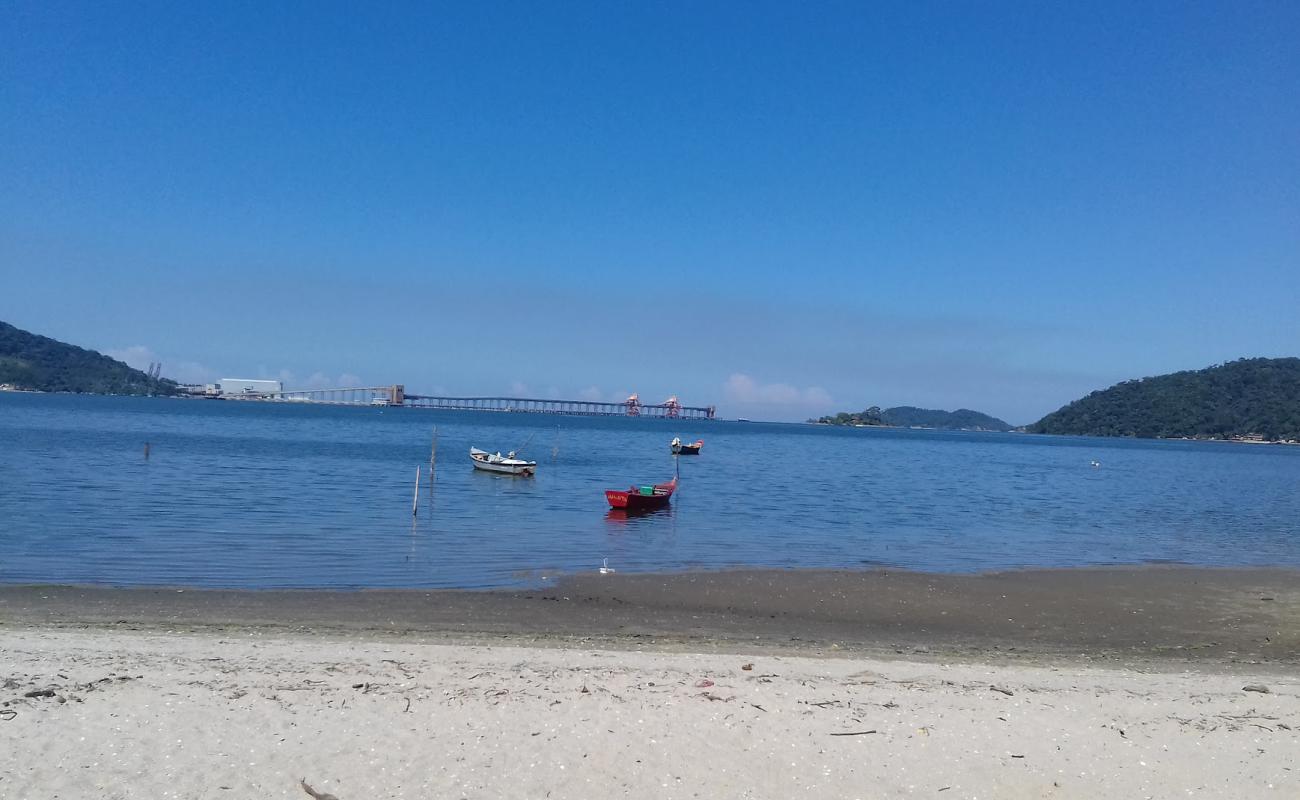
[0,567,1300,670]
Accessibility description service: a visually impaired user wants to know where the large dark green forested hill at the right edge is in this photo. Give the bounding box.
[1026,358,1300,441]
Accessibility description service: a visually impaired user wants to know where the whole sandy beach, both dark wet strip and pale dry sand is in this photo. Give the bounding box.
[0,570,1300,800]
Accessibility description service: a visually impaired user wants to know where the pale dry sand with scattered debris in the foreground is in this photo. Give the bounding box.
[0,628,1300,800]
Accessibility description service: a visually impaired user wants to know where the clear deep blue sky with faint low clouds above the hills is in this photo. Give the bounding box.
[0,3,1300,423]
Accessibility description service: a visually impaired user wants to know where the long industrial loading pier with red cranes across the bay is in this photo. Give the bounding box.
[221,384,718,419]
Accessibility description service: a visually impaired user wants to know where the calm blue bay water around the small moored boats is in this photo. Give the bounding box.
[0,394,1300,587]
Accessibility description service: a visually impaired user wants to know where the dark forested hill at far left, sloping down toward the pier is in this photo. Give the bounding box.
[0,323,176,394]
